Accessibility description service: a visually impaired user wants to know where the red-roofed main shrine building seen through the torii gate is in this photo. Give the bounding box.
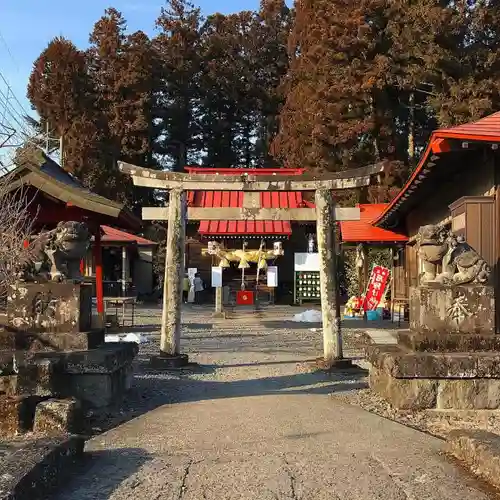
[185,167,319,303]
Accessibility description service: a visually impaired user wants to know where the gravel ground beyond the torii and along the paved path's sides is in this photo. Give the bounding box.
[92,306,500,438]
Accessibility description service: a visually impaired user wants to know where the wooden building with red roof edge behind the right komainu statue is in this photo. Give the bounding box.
[372,112,500,332]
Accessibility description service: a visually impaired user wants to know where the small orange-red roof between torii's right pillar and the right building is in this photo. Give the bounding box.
[340,203,408,243]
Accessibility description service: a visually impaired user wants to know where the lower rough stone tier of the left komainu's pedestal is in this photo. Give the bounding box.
[0,343,138,436]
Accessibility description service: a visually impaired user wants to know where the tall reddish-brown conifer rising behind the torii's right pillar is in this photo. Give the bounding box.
[273,0,387,170]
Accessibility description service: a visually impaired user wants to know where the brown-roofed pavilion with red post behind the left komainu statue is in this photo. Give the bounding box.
[8,151,141,321]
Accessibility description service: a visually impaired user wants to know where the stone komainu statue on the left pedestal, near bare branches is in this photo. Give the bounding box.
[19,221,91,281]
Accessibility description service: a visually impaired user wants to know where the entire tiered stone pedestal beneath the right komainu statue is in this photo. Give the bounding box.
[367,284,500,410]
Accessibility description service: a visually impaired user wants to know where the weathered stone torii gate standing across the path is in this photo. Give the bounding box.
[120,163,384,367]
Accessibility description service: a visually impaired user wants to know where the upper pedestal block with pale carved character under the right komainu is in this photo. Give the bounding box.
[410,284,495,334]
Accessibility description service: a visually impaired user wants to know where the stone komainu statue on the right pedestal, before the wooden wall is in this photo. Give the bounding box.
[417,225,491,285]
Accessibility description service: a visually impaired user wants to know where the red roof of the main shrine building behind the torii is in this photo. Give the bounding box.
[186,167,311,236]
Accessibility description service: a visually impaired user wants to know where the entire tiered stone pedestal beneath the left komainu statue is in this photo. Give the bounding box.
[0,283,138,436]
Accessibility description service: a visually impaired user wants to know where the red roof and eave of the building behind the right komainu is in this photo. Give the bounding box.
[373,112,500,226]
